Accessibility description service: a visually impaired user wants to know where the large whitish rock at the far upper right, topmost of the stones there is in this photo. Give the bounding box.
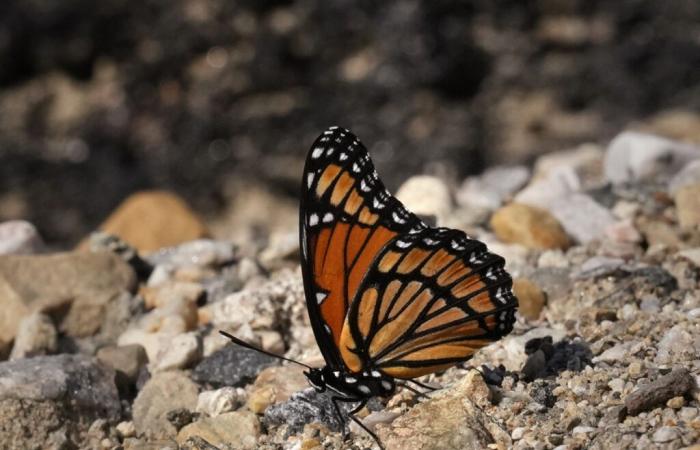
[604,131,700,184]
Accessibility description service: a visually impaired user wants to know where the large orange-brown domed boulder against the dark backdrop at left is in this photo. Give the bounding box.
[91,191,208,253]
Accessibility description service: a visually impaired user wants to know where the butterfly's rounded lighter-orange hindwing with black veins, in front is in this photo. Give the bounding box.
[340,228,517,378]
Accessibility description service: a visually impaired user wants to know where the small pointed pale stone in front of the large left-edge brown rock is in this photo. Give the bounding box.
[10,313,57,360]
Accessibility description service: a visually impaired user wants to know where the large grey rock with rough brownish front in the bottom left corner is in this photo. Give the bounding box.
[0,355,121,448]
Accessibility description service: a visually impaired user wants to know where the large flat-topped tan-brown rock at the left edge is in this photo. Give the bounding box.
[0,252,136,347]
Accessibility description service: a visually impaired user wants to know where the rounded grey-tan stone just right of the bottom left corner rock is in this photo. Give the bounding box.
[133,371,197,439]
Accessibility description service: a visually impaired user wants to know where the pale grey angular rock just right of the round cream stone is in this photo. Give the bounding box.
[456,166,530,210]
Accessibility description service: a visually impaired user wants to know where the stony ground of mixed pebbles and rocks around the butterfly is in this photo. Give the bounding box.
[0,128,700,450]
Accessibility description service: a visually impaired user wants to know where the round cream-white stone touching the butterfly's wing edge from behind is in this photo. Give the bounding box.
[396,175,452,224]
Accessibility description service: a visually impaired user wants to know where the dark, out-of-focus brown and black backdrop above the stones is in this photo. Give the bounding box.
[0,0,700,248]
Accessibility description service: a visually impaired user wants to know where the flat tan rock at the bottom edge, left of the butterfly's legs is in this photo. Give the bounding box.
[177,411,260,450]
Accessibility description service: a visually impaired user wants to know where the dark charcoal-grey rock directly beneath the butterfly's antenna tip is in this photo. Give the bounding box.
[192,344,278,387]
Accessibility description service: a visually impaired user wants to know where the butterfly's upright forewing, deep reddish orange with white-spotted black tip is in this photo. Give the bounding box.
[299,127,426,368]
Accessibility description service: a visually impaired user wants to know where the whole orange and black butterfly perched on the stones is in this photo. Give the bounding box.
[222,126,518,442]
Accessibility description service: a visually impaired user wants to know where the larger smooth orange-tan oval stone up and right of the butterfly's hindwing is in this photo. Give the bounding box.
[491,203,569,249]
